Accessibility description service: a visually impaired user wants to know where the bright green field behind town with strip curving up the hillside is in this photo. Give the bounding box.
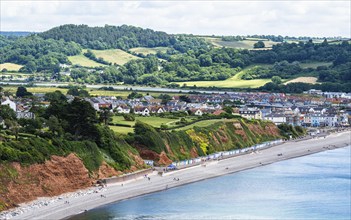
[176,65,271,88]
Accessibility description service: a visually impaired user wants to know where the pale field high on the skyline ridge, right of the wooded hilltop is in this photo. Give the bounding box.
[204,37,277,50]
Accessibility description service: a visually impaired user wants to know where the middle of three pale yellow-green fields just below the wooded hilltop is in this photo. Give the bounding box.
[91,49,140,65]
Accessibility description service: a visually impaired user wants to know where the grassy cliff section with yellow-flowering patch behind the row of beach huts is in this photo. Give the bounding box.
[135,119,280,165]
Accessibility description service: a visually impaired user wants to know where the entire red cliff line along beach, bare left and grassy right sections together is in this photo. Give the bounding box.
[0,119,280,211]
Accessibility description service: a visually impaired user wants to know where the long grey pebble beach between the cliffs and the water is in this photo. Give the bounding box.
[0,130,351,219]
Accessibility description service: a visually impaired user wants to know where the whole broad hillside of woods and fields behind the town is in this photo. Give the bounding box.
[0,24,351,91]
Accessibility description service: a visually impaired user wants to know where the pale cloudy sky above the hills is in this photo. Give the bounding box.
[0,0,351,38]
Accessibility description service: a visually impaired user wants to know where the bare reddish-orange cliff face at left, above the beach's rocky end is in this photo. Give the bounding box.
[0,154,118,211]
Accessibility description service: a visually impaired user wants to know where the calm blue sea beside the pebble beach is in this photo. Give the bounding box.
[70,146,351,220]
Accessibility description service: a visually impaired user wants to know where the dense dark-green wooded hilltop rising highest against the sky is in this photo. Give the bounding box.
[39,24,174,50]
